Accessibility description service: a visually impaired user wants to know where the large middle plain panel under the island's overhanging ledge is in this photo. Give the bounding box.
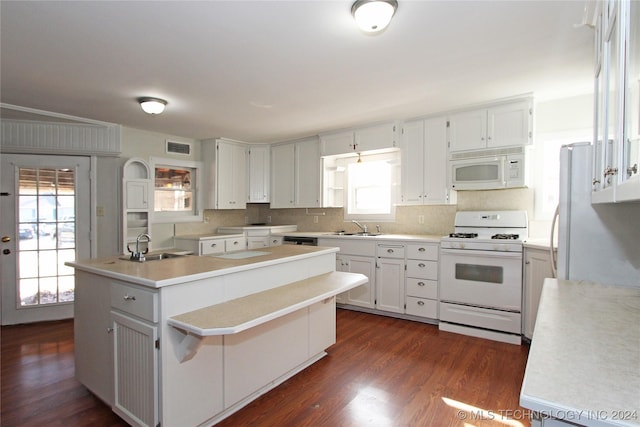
[224,310,309,408]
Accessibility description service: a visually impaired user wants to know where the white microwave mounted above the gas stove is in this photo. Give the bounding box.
[449,150,526,190]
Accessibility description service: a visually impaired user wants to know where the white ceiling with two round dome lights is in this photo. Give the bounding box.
[0,0,593,142]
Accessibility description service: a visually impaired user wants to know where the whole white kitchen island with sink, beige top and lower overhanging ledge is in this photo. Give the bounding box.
[68,246,367,426]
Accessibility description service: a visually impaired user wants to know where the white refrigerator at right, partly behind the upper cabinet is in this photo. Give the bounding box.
[558,143,640,287]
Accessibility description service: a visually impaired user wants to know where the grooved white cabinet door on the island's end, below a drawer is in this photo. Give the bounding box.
[111,311,158,427]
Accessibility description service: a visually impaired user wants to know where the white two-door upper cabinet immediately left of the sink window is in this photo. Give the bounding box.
[271,138,321,209]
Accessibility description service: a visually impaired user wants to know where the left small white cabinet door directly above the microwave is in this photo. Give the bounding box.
[449,109,487,151]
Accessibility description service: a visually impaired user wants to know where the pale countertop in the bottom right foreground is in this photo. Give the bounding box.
[520,279,640,426]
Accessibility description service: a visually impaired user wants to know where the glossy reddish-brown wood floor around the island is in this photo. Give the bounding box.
[0,310,530,427]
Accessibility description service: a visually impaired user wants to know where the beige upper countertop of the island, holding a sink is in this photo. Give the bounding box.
[65,245,338,288]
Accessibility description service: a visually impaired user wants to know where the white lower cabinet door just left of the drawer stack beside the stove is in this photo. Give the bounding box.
[376,258,405,313]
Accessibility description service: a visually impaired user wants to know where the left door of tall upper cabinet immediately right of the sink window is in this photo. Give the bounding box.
[401,120,424,205]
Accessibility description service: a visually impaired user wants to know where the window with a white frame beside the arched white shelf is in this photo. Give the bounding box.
[151,158,202,222]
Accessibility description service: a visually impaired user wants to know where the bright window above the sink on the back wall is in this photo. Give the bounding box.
[344,152,399,221]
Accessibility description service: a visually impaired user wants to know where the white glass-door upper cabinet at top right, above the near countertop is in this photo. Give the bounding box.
[592,0,640,203]
